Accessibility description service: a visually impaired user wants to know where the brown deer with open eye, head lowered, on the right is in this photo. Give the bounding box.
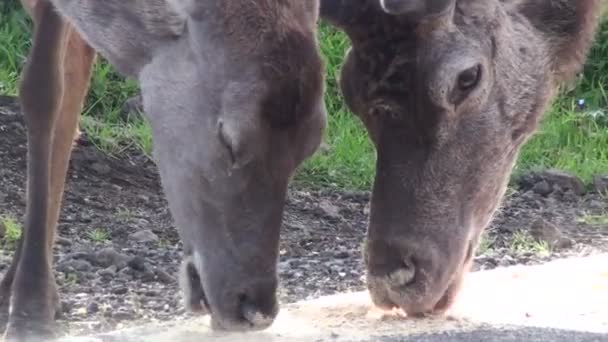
[320,0,600,316]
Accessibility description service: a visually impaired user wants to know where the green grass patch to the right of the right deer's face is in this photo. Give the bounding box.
[515,21,608,182]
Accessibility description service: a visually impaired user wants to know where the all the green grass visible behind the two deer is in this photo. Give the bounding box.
[0,5,608,189]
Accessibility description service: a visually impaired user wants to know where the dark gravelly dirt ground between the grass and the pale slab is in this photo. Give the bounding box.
[0,99,608,333]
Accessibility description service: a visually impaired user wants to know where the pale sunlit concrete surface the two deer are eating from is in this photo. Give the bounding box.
[59,254,608,342]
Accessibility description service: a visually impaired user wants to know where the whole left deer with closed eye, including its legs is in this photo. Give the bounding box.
[0,0,326,341]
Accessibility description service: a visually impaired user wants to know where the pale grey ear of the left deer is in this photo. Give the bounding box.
[51,0,186,76]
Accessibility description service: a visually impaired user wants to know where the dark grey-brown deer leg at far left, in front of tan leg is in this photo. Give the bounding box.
[6,1,67,341]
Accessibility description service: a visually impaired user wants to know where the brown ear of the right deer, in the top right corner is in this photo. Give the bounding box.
[519,0,601,82]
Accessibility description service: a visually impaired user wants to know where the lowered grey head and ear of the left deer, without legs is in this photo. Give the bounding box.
[53,0,326,330]
